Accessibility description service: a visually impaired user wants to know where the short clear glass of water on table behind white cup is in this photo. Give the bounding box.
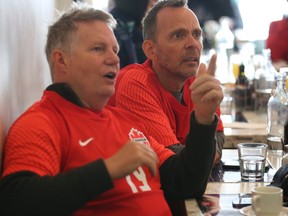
[237,143,268,182]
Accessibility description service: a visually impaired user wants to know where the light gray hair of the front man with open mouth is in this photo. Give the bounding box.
[45,5,117,79]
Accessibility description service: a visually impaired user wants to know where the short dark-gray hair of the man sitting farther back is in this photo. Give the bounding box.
[142,0,188,40]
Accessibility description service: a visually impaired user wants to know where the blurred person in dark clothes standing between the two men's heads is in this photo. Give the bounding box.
[110,0,157,68]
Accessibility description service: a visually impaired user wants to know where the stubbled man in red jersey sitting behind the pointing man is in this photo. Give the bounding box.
[108,0,225,165]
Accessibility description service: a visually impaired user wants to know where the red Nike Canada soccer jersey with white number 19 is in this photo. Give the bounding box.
[4,91,173,216]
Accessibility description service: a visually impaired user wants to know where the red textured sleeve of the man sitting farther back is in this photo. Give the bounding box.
[115,70,179,146]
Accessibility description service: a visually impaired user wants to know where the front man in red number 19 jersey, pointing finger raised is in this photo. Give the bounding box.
[0,2,223,216]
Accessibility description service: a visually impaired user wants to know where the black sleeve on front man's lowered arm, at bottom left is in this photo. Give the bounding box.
[0,159,113,216]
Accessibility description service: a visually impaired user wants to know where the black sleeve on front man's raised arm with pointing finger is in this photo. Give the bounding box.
[160,112,218,200]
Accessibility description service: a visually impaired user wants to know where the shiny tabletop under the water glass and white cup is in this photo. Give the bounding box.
[185,149,277,216]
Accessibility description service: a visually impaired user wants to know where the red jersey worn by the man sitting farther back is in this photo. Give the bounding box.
[108,60,223,146]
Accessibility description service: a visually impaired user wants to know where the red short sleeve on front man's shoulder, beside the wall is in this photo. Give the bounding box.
[3,113,60,176]
